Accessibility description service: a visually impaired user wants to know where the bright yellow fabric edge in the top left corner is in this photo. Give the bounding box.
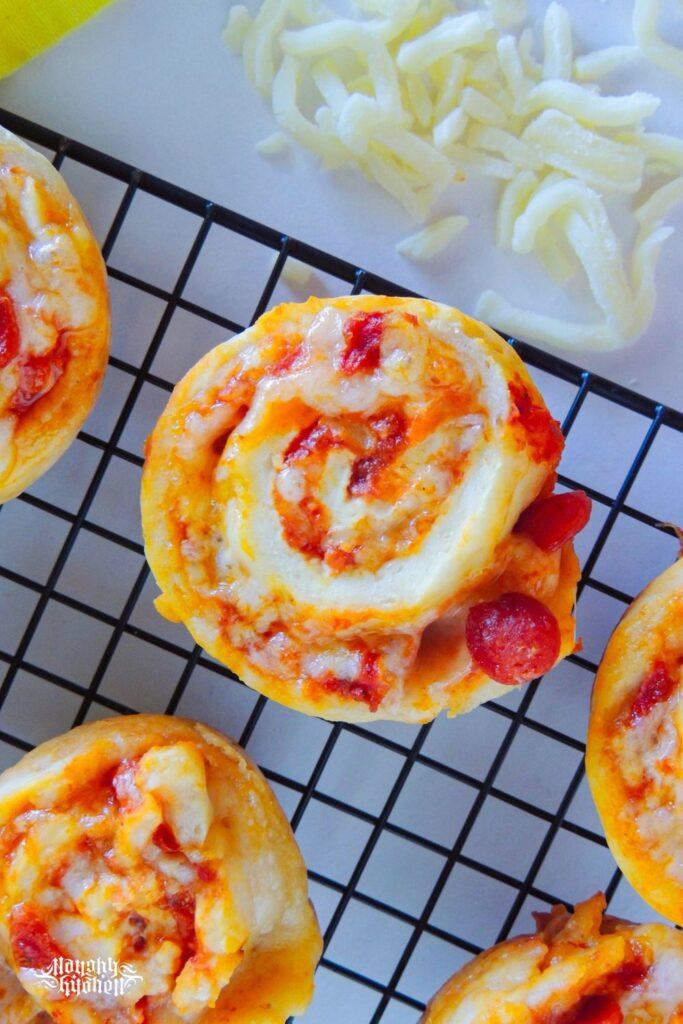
[0,0,111,78]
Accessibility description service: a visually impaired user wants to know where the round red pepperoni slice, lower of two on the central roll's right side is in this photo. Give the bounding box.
[465,592,560,686]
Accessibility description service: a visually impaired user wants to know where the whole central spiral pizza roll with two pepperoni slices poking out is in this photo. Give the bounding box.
[142,296,590,722]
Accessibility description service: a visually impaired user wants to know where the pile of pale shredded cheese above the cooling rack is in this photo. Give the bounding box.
[224,0,683,350]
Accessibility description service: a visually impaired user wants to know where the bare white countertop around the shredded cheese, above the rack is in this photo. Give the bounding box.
[0,0,683,408]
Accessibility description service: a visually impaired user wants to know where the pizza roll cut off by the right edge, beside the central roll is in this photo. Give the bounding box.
[586,558,683,925]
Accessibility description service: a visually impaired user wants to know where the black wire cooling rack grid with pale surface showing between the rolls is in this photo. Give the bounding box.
[0,111,683,1024]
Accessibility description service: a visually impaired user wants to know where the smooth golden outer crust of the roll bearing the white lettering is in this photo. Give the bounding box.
[0,715,321,1024]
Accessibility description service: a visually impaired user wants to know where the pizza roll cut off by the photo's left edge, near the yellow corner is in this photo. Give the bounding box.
[0,127,110,503]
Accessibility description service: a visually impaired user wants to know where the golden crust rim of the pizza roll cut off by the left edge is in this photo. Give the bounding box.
[0,128,110,503]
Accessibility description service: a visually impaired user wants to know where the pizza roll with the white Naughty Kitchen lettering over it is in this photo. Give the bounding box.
[0,715,321,1024]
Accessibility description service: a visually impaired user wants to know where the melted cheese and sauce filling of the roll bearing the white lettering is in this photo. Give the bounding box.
[0,741,249,1024]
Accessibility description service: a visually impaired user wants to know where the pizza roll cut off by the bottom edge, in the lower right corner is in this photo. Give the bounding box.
[421,893,683,1024]
